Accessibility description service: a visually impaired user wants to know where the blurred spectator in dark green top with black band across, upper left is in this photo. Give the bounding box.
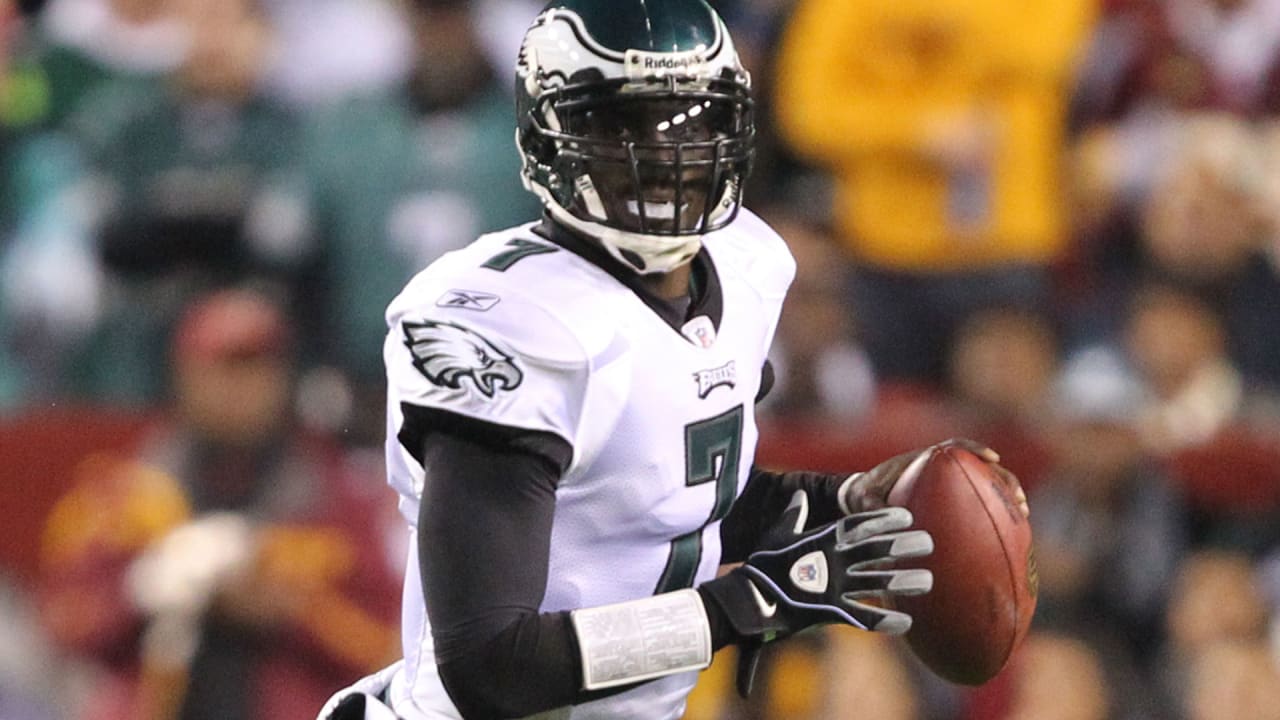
[46,0,313,404]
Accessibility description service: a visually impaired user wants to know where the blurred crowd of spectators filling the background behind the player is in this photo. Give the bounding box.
[0,0,1280,720]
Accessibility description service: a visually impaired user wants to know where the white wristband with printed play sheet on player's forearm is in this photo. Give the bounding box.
[570,589,712,691]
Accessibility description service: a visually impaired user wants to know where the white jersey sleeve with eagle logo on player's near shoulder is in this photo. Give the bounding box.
[383,233,589,512]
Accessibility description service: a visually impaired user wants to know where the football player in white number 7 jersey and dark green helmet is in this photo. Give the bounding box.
[321,0,1029,720]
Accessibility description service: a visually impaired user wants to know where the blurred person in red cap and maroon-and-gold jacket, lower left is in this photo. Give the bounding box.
[42,290,401,720]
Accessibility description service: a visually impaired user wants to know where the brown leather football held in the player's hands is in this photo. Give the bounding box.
[888,443,1037,685]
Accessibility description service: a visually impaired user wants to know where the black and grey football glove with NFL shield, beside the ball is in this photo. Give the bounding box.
[699,491,933,697]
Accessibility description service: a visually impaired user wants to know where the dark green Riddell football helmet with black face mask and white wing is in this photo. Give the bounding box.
[516,0,755,273]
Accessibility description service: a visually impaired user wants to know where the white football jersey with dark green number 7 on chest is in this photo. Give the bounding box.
[384,204,795,720]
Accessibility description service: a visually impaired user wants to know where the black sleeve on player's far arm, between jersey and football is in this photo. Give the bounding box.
[721,468,849,562]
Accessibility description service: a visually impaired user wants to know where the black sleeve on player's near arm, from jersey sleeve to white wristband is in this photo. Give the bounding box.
[419,417,626,719]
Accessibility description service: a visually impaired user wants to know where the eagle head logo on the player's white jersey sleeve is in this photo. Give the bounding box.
[403,320,525,397]
